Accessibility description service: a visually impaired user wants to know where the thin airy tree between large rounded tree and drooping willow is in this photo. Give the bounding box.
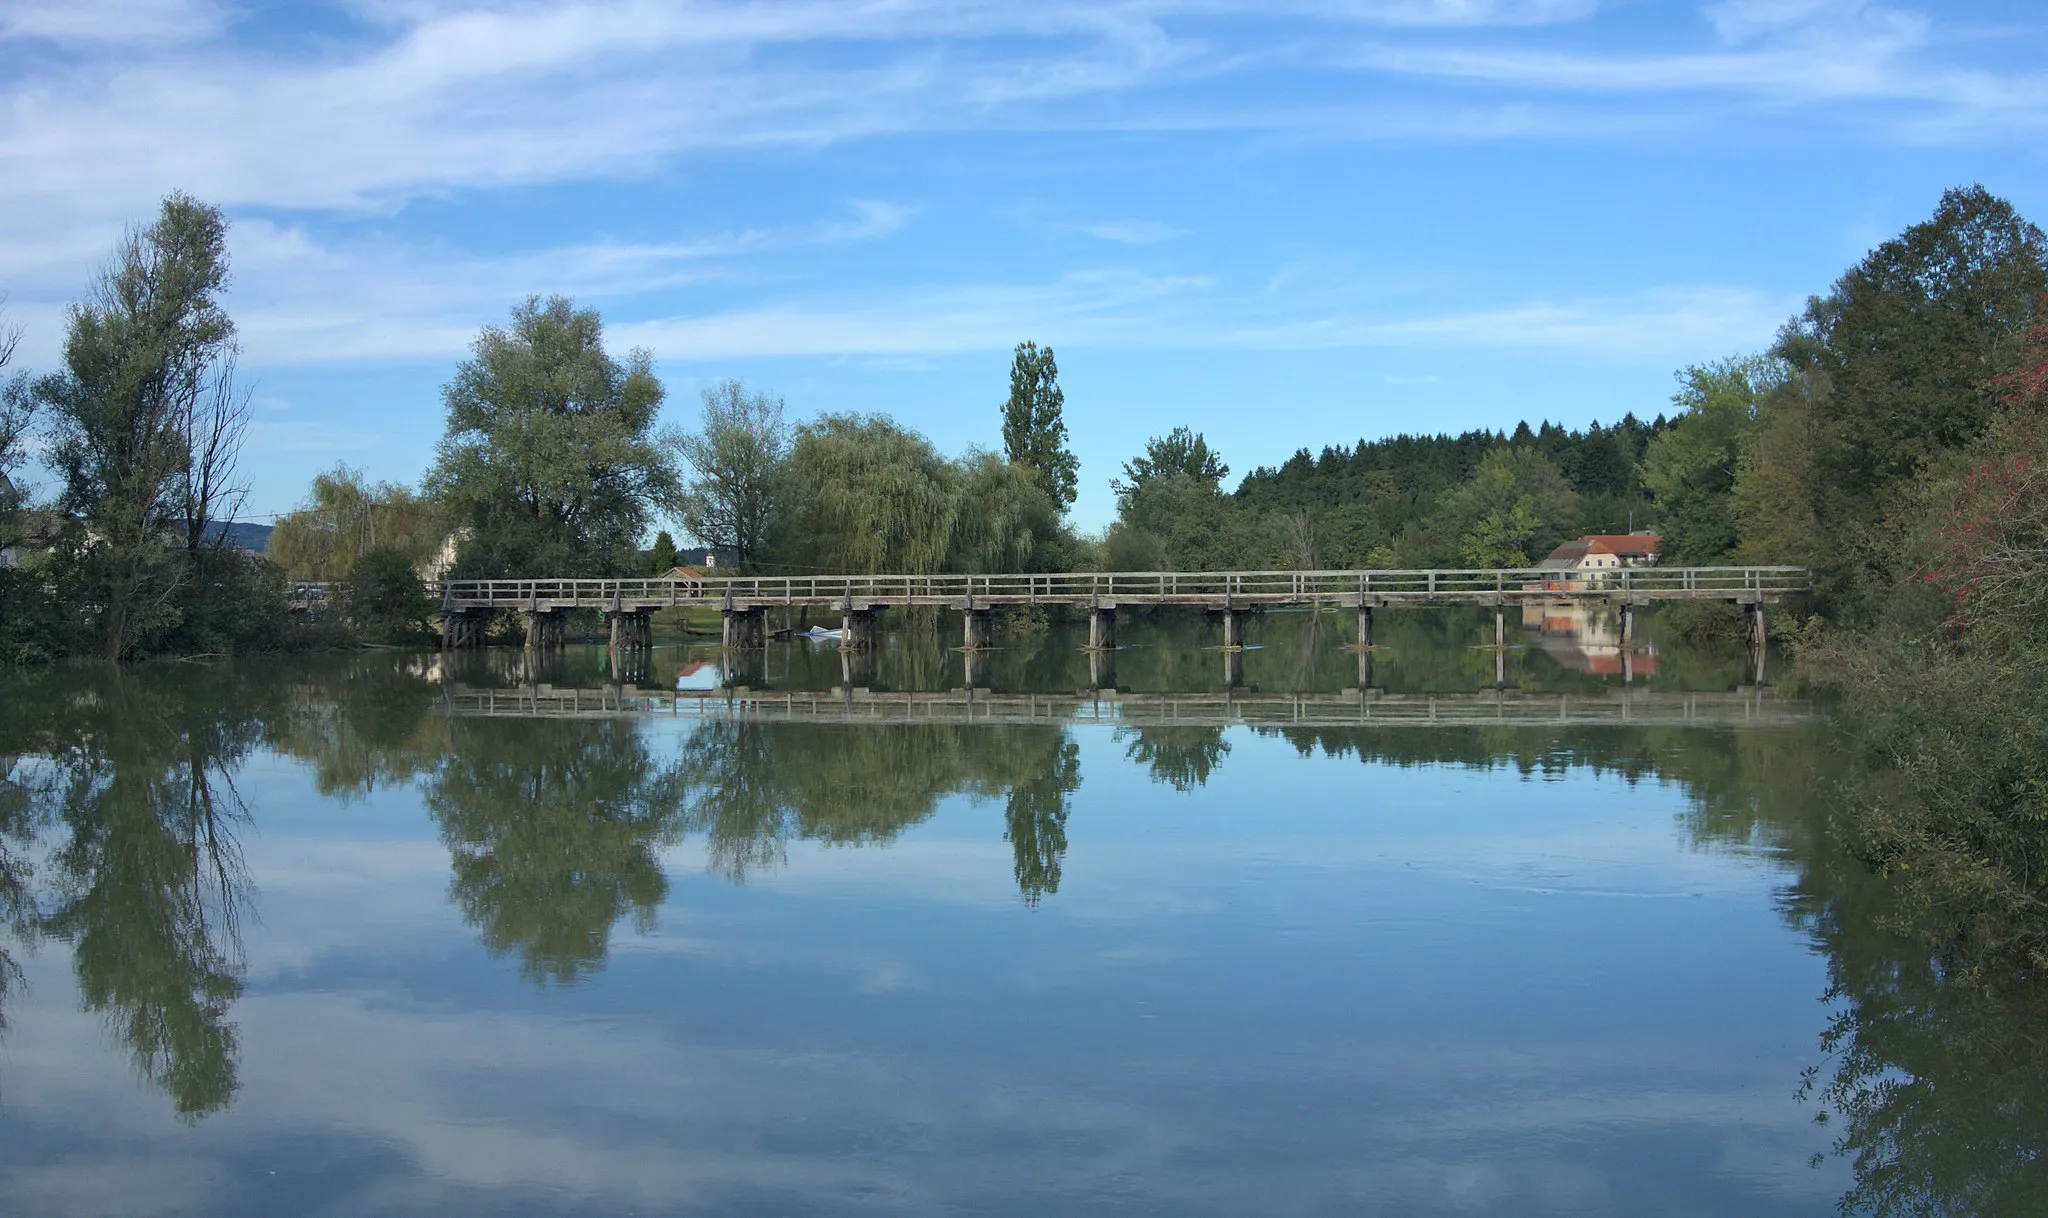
[668,381,788,567]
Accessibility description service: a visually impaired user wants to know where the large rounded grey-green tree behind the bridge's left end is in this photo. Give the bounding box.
[426,297,676,575]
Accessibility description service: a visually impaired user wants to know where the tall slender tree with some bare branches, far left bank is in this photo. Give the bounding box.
[35,194,240,659]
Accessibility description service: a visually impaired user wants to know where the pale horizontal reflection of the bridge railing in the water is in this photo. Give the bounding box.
[442,684,1825,727]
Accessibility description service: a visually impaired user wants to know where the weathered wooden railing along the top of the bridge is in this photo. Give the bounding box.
[430,567,1812,608]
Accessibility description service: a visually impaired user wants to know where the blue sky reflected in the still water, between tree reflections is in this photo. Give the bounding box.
[0,725,1845,1214]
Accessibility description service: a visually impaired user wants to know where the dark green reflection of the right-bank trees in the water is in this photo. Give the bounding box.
[1667,731,2048,1218]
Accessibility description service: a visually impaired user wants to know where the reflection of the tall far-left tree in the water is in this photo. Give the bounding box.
[0,669,264,1120]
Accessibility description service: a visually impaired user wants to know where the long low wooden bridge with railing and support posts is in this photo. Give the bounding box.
[432,567,1812,651]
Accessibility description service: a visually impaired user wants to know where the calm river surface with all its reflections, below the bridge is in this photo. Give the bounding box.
[0,614,2042,1216]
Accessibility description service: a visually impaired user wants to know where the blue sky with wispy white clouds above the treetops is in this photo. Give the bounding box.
[0,0,2048,528]
